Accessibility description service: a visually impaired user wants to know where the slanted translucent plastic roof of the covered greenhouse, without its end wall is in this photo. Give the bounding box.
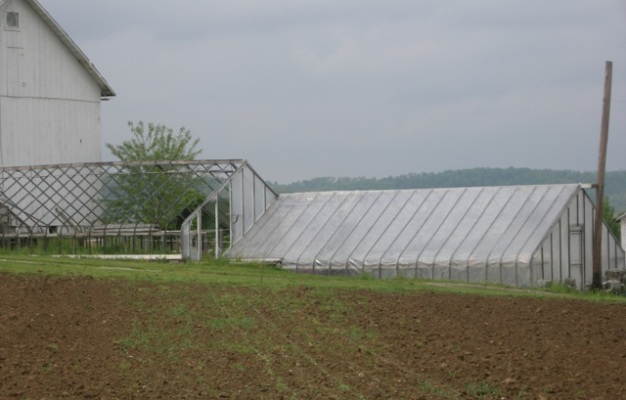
[230,185,580,271]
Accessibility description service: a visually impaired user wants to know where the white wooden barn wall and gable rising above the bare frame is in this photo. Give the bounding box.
[0,0,115,167]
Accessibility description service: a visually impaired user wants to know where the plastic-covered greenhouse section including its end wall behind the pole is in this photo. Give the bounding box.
[229,185,624,287]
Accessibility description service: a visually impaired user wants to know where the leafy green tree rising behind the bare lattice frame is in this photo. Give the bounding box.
[103,121,204,229]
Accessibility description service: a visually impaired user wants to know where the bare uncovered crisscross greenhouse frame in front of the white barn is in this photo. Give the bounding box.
[0,160,273,254]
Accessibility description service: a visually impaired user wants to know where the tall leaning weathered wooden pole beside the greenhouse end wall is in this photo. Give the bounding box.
[592,61,613,289]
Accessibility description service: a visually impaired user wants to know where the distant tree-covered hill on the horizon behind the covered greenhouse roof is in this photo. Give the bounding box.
[270,168,626,213]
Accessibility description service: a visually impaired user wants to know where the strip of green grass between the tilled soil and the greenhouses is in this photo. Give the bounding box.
[0,253,626,303]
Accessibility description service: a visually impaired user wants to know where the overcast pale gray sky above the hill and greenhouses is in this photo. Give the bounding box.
[40,0,626,183]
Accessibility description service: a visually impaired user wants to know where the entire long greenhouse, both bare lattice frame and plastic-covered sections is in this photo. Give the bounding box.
[0,160,624,289]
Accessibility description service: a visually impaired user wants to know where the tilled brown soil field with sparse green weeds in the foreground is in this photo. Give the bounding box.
[0,274,626,399]
